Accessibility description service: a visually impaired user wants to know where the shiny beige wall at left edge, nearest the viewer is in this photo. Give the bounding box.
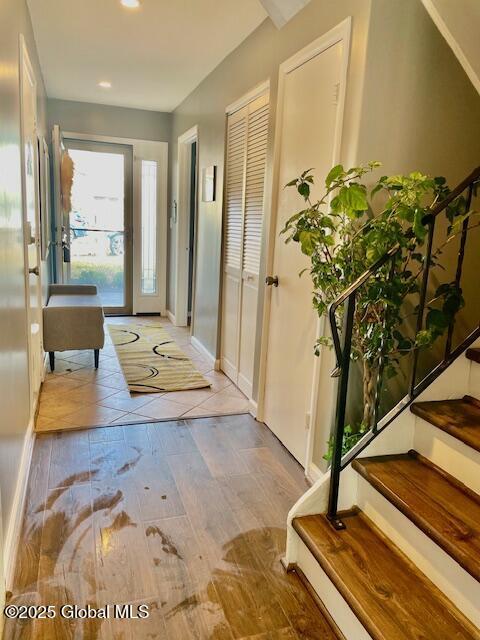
[0,0,46,568]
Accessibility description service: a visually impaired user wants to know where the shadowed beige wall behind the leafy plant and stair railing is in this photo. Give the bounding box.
[313,0,480,468]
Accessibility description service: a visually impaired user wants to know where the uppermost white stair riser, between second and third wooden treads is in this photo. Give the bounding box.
[413,416,480,493]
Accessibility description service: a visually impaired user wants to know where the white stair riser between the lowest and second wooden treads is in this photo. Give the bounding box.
[357,474,480,627]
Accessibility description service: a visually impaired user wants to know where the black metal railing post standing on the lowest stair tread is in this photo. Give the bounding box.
[327,292,355,529]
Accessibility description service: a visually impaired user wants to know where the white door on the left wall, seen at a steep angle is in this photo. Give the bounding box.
[20,40,43,416]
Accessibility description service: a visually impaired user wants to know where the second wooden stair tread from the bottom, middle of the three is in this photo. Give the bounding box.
[352,451,480,581]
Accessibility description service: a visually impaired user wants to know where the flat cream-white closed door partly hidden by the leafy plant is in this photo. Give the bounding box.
[264,41,344,465]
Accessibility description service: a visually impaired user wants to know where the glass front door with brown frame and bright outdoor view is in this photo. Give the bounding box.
[64,140,132,314]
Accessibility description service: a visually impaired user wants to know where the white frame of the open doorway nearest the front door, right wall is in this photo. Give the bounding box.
[172,125,198,332]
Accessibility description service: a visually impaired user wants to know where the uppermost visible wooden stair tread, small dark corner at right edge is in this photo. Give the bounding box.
[410,396,480,451]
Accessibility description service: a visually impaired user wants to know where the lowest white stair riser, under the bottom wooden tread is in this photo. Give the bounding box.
[295,533,372,640]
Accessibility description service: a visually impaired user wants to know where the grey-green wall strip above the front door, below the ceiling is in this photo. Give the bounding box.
[48,98,172,142]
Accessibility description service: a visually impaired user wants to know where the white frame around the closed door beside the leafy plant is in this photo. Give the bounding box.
[257,16,352,475]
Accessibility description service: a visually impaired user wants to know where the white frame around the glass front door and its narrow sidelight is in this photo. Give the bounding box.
[63,131,168,315]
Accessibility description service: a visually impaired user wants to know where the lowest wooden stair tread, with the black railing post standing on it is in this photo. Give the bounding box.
[293,510,480,640]
